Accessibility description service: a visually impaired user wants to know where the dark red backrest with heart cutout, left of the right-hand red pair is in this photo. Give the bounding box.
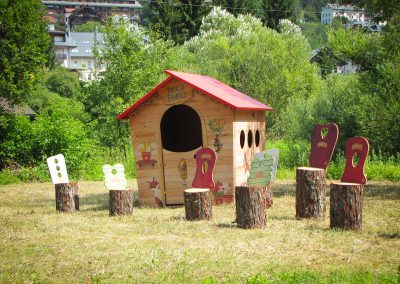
[310,123,339,170]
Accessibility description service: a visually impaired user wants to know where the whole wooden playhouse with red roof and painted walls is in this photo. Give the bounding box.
[118,70,272,206]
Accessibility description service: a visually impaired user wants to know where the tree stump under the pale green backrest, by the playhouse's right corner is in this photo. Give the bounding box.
[235,186,268,229]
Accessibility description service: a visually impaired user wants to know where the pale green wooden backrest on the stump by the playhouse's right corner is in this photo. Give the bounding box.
[247,152,274,187]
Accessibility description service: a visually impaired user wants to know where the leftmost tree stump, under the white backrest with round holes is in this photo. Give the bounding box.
[55,182,79,212]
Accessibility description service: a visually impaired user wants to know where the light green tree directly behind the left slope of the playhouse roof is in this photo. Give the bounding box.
[82,21,171,150]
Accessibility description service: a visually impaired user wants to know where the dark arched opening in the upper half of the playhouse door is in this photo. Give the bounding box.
[160,105,203,152]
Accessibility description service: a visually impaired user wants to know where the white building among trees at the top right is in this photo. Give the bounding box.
[321,4,365,25]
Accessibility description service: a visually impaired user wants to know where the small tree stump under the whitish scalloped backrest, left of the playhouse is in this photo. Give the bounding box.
[109,189,133,216]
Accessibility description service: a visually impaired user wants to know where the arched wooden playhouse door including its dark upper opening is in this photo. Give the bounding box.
[160,104,203,205]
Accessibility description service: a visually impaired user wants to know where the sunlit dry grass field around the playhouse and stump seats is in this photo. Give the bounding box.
[0,181,400,283]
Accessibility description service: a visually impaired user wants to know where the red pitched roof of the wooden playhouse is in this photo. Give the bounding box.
[118,70,272,119]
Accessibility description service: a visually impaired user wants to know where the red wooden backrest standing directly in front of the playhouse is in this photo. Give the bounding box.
[192,148,217,190]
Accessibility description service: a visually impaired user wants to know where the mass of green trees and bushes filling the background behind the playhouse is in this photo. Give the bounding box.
[0,0,400,184]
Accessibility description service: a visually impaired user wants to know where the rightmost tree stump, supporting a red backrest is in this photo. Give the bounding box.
[330,182,363,230]
